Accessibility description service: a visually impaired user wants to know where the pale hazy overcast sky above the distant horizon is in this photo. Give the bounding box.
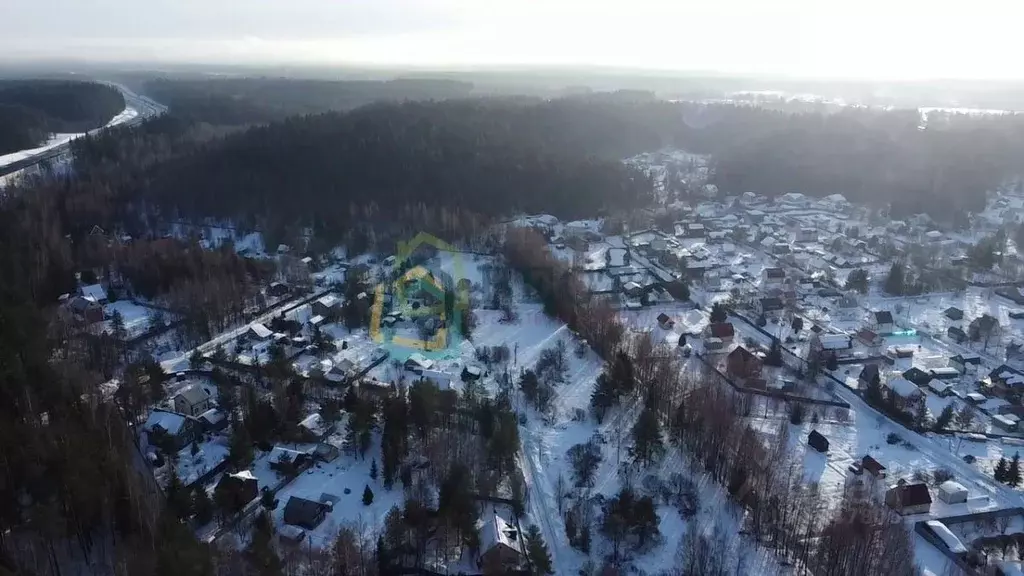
[8,0,1024,79]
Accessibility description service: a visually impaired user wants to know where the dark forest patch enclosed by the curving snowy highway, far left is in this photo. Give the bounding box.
[0,80,125,154]
